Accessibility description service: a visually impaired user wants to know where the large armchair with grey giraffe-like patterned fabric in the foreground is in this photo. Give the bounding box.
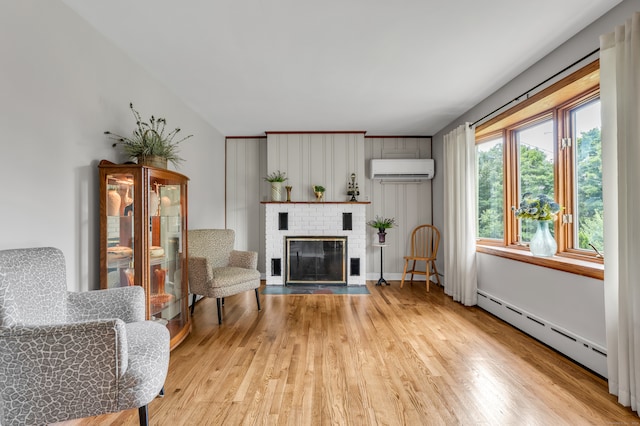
[0,247,169,425]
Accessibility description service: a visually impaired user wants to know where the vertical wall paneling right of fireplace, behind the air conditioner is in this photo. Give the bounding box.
[365,137,432,279]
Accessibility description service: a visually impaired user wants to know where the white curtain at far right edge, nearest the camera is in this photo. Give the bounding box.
[600,13,640,411]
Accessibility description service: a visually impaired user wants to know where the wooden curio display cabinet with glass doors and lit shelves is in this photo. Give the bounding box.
[98,160,191,349]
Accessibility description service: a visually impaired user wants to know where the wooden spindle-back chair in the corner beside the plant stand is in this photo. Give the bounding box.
[400,225,441,291]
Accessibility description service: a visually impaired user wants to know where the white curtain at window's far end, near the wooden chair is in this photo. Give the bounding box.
[443,124,478,306]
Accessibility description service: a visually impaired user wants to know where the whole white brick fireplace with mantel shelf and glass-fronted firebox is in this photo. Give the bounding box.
[263,202,370,285]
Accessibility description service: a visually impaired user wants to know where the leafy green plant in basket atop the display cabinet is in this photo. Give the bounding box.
[104,103,193,169]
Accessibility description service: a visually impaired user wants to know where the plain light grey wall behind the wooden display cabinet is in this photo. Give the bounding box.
[0,0,224,290]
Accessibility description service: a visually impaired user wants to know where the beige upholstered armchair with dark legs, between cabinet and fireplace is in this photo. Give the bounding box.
[187,229,260,324]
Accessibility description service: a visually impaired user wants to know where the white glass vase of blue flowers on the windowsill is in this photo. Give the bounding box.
[515,192,562,257]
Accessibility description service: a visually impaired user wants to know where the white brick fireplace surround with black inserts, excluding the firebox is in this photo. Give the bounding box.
[264,202,369,285]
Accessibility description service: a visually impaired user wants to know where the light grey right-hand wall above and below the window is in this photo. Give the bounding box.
[433,0,640,368]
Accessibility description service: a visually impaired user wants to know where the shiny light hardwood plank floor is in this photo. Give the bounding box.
[58,282,640,426]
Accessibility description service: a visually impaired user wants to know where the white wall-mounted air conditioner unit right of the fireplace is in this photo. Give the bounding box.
[369,158,435,182]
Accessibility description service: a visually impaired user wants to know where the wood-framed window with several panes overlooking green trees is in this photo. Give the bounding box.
[476,61,603,278]
